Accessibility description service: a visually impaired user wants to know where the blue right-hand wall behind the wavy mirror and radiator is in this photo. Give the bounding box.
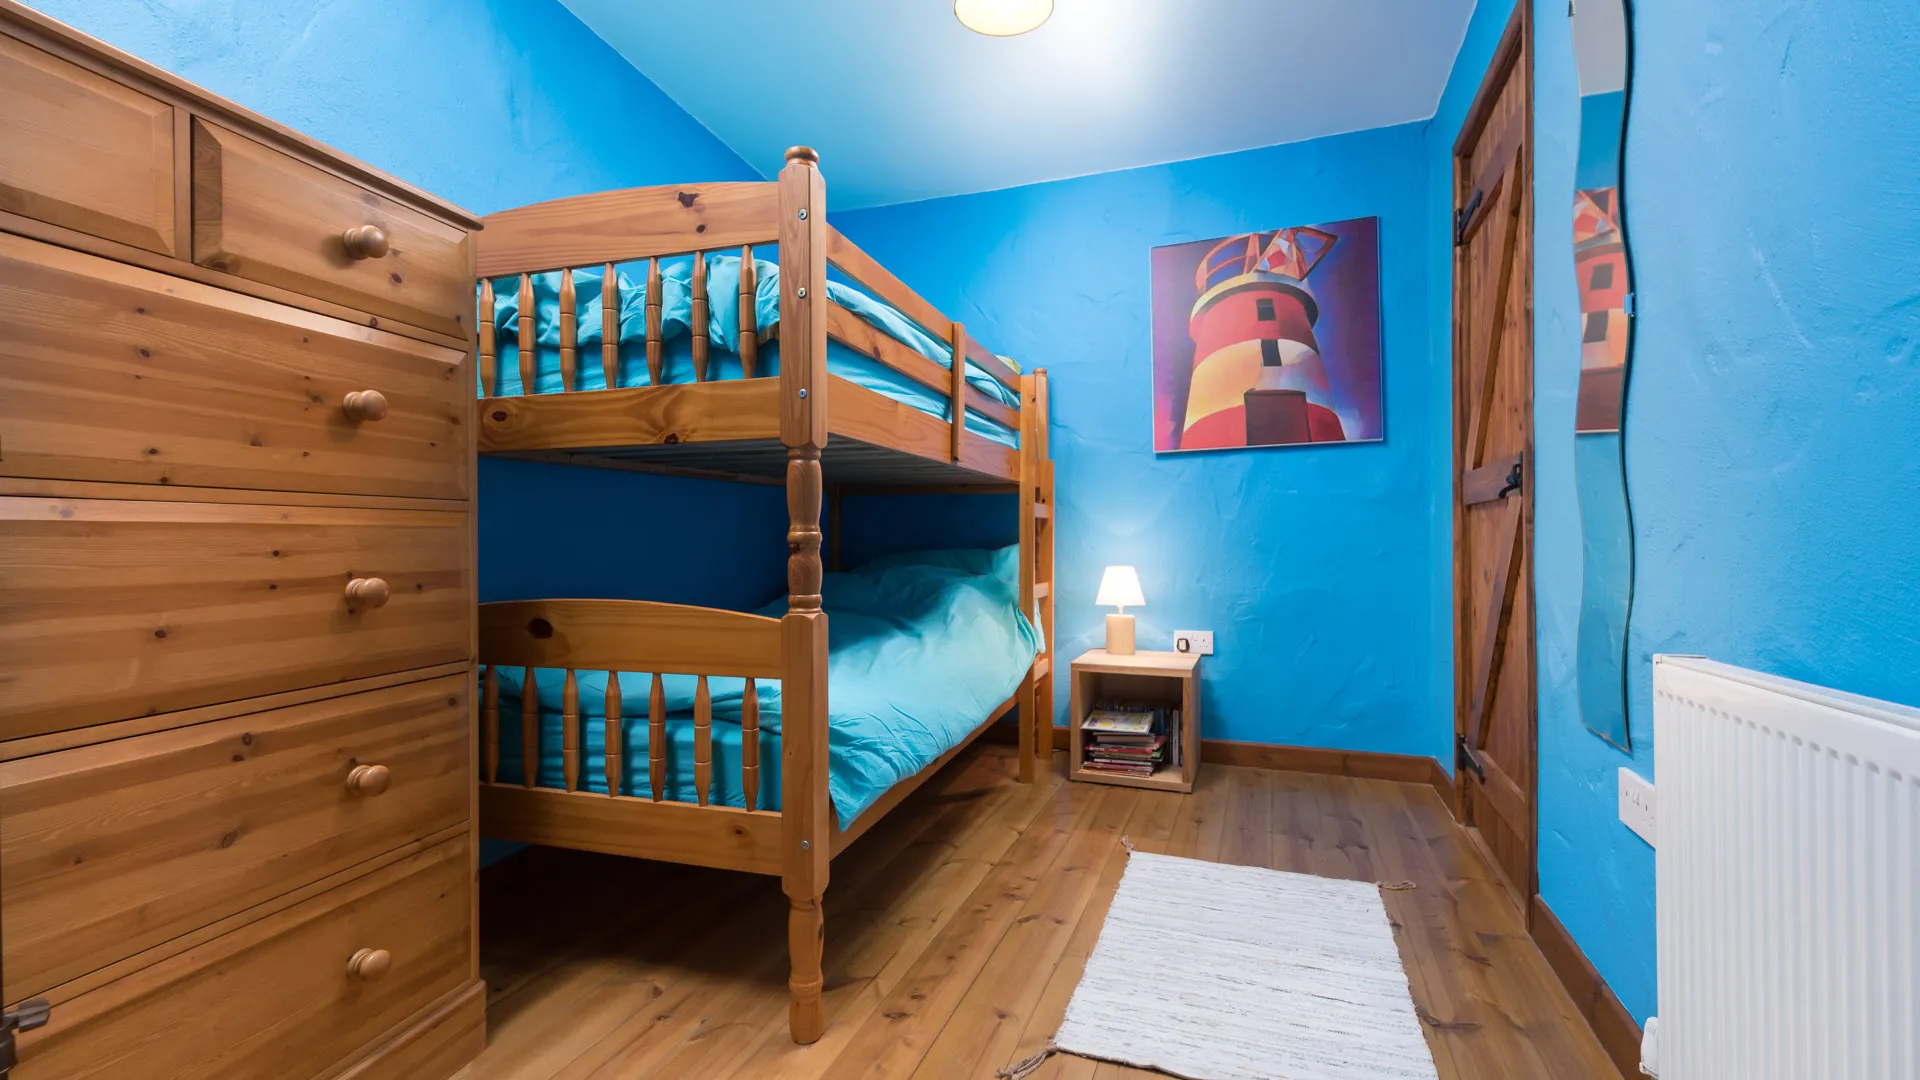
[1534,0,1920,1019]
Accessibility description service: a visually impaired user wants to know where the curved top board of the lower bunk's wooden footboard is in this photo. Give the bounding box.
[480,600,781,678]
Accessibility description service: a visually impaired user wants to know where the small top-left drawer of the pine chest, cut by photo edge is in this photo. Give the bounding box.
[0,35,175,256]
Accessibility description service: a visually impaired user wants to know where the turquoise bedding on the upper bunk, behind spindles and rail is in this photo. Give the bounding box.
[480,256,1020,446]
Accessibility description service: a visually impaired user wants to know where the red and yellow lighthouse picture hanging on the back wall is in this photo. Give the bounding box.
[1152,217,1382,454]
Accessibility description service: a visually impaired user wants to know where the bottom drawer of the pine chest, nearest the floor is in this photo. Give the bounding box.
[13,836,472,1080]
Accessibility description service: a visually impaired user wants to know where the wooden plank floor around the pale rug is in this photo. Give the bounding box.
[461,746,1619,1080]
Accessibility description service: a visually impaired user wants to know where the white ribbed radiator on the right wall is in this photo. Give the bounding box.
[1653,657,1920,1080]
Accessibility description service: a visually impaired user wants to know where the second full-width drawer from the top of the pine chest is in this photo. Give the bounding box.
[0,496,474,738]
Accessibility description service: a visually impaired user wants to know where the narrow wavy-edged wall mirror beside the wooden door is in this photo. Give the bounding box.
[1569,0,1634,749]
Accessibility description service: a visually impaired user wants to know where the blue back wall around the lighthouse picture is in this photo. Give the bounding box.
[826,125,1450,755]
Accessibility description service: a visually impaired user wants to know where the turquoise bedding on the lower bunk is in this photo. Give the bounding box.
[487,548,1041,824]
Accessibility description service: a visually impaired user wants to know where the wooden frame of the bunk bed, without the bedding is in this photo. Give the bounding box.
[476,146,1054,1043]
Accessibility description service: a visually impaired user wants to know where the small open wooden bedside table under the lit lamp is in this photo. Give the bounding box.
[1068,650,1200,794]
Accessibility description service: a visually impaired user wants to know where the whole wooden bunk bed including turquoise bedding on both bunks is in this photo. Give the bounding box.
[476,148,1054,1043]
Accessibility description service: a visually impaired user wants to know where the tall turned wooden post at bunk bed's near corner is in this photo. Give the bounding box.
[780,146,833,1043]
